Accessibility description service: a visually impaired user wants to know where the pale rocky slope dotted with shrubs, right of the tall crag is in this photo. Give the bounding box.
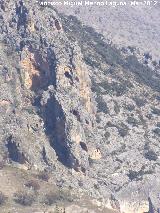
[59,13,160,212]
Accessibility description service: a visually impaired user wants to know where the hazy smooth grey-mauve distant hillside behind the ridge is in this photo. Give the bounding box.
[57,0,160,61]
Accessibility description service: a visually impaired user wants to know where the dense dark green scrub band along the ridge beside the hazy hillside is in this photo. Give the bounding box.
[61,16,160,91]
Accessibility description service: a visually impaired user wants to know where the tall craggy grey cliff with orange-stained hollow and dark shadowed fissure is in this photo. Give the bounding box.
[1,1,96,170]
